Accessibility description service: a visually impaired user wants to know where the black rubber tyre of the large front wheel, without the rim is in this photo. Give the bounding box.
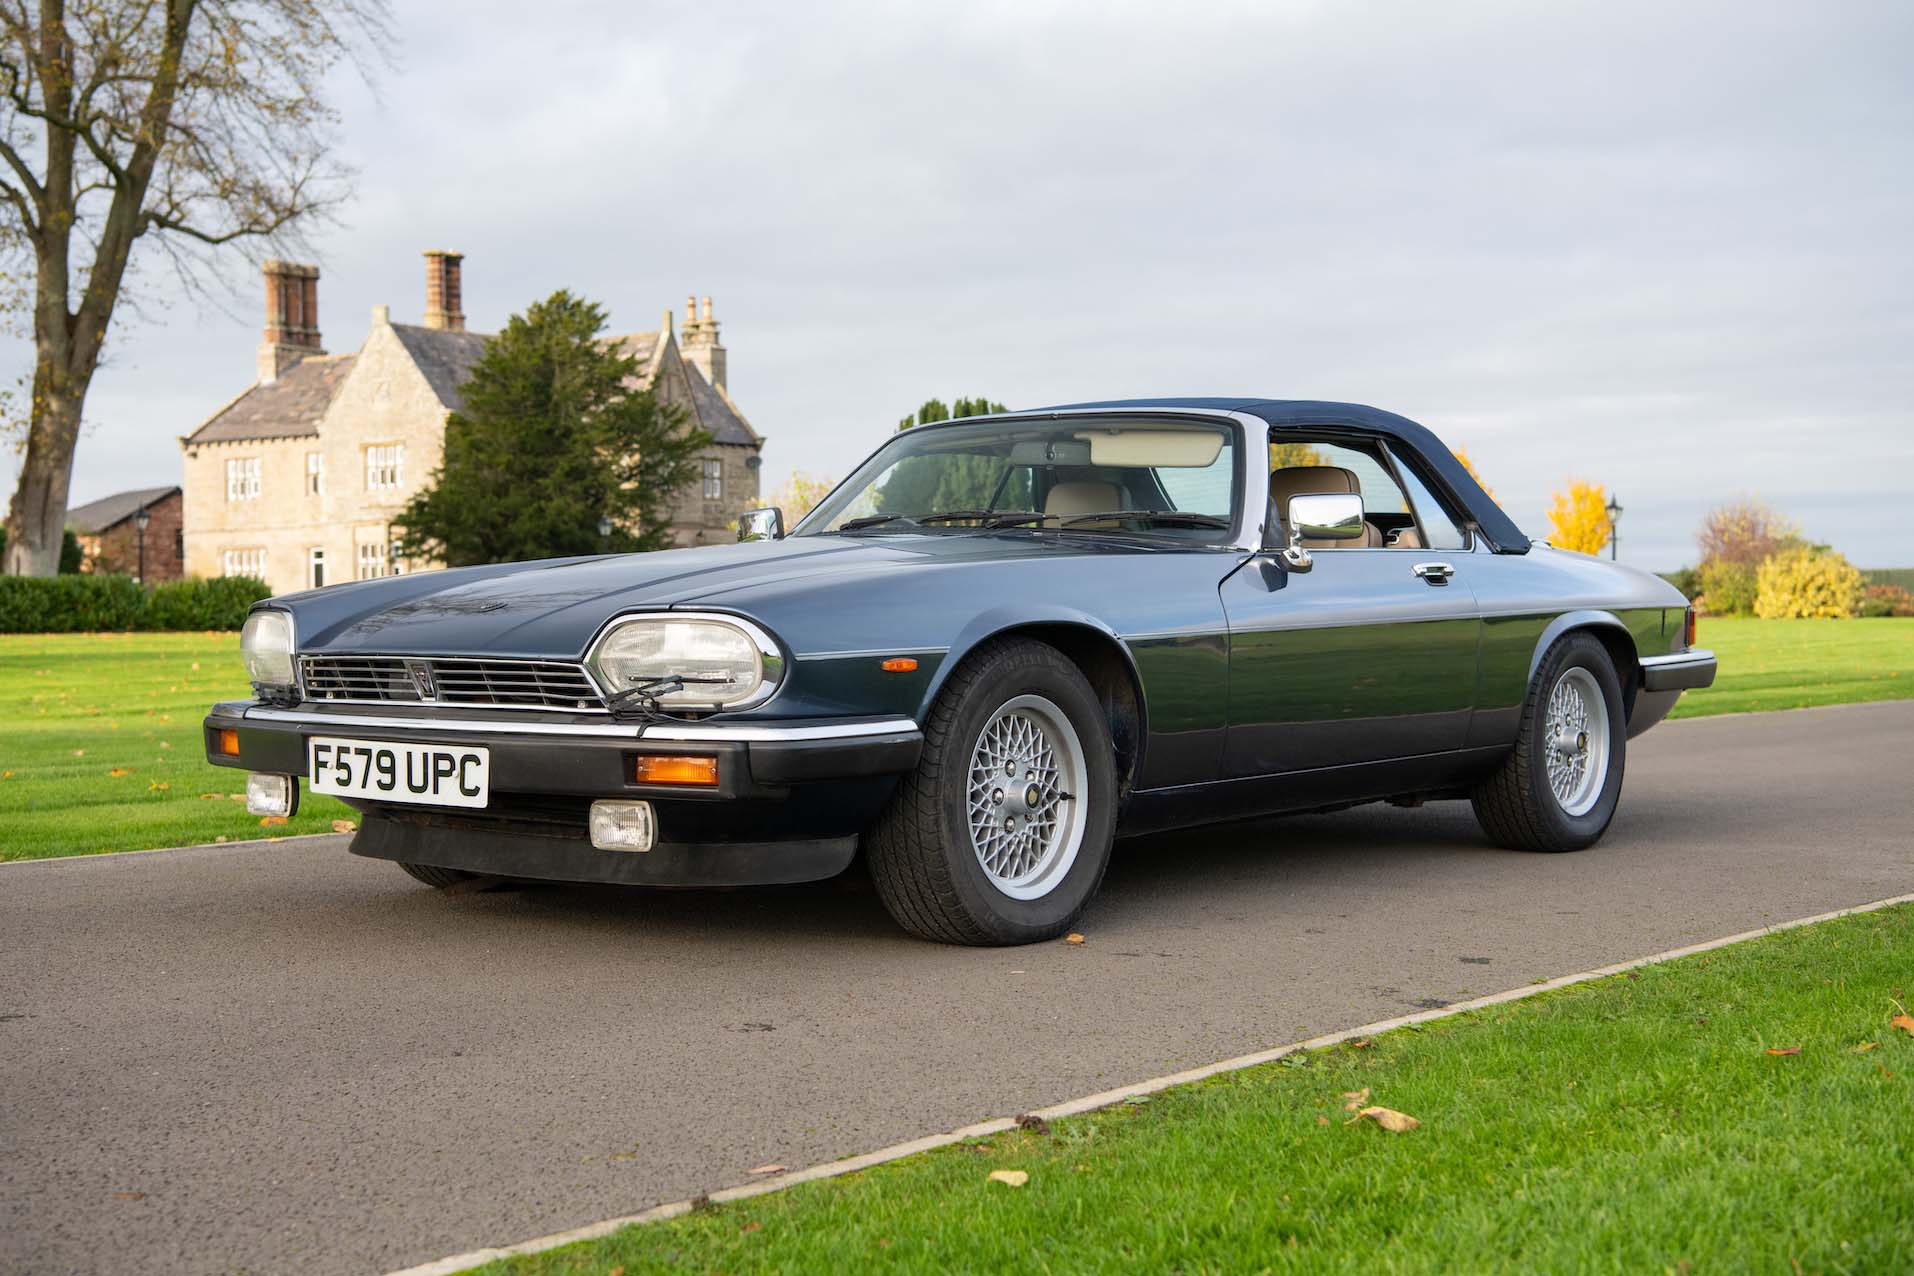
[863,639,1116,945]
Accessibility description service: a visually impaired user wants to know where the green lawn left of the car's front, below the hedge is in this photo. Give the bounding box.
[0,633,356,861]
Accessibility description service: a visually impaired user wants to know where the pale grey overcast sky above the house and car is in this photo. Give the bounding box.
[18,0,1914,568]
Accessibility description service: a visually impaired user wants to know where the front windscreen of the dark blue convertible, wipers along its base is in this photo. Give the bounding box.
[792,417,1236,541]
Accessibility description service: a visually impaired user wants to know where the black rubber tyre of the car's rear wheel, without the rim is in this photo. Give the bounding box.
[1470,633,1627,851]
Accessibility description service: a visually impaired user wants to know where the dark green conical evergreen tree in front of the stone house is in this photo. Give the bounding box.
[400,291,710,566]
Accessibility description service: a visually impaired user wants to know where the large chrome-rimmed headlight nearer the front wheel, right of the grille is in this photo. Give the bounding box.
[590,616,785,710]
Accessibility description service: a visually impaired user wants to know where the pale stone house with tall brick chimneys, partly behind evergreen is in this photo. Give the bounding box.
[180,253,764,593]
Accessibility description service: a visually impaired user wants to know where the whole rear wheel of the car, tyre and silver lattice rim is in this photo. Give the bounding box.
[1470,633,1627,851]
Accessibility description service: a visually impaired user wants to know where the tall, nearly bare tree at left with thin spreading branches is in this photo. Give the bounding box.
[0,0,390,576]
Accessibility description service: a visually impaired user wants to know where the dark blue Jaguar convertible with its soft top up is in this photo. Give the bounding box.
[205,400,1715,943]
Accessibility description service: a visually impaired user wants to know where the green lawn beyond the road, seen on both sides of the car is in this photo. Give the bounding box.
[0,618,1914,859]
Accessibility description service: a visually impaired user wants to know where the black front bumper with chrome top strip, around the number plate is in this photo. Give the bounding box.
[205,700,923,886]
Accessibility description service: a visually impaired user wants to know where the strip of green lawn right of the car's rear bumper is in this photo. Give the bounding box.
[1671,616,1914,717]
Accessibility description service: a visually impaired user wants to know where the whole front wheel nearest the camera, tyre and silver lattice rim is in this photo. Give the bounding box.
[865,639,1116,945]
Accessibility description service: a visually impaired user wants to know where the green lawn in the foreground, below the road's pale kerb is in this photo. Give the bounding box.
[480,907,1914,1276]
